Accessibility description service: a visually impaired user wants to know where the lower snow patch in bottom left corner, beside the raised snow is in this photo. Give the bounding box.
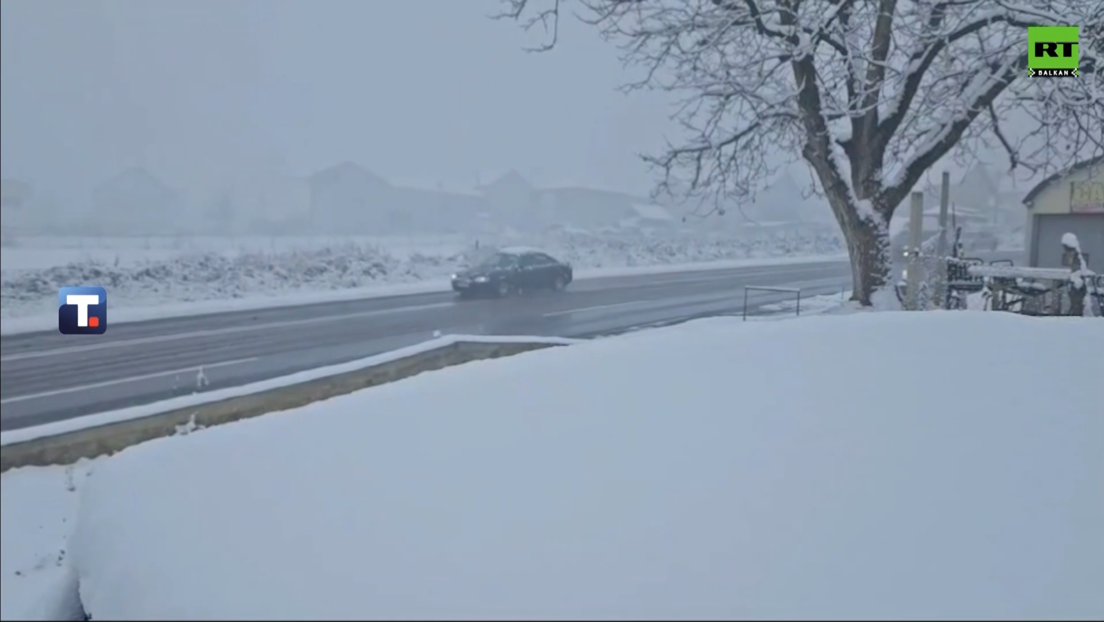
[0,462,94,620]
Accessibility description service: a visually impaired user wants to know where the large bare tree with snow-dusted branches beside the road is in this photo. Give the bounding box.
[499,0,1104,305]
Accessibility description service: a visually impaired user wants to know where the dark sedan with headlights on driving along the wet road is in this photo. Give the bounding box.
[453,249,574,298]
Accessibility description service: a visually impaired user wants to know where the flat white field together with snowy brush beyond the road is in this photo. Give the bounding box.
[0,228,845,327]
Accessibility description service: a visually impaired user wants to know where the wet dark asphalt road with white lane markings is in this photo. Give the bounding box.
[0,250,1024,430]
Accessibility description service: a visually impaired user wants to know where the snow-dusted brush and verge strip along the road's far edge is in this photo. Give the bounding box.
[0,230,843,319]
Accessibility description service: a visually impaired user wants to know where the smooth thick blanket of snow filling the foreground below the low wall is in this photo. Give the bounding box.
[0,312,1104,620]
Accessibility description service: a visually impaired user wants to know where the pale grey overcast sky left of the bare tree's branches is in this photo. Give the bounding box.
[0,0,671,205]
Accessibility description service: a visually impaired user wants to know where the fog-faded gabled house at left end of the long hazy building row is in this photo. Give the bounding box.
[307,161,397,233]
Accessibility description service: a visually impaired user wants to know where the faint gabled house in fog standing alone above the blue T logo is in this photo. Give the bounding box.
[88,167,181,235]
